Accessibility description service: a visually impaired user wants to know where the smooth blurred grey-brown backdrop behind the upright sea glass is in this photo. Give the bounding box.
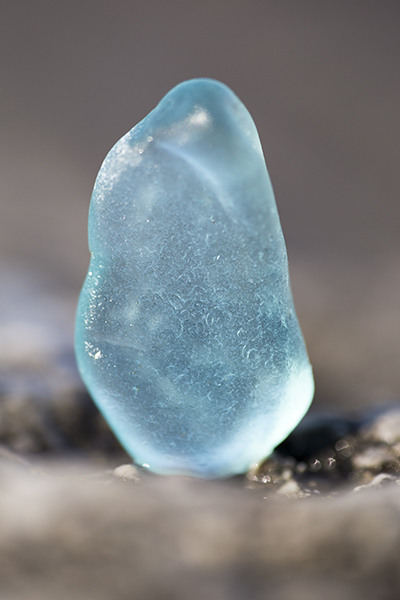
[0,0,400,418]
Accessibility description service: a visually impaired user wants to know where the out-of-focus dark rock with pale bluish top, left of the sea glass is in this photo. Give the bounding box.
[0,266,126,458]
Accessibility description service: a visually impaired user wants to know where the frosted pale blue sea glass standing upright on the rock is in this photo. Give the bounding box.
[76,79,313,477]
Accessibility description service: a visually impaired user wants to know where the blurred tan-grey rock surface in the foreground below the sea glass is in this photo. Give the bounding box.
[0,460,400,600]
